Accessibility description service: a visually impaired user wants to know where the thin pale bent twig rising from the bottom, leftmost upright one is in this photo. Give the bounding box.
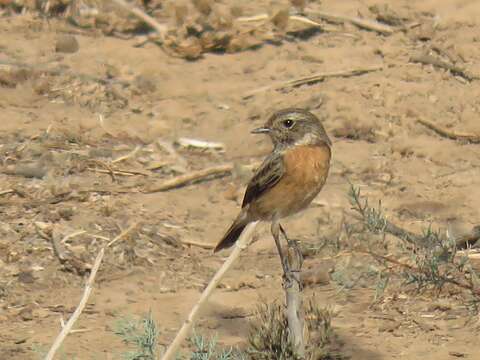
[45,224,137,360]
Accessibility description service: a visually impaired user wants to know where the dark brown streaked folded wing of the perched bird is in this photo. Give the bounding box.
[242,153,285,208]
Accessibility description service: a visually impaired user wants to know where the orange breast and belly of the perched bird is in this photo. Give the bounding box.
[250,145,331,220]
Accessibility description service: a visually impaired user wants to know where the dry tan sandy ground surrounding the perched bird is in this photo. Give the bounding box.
[0,0,480,360]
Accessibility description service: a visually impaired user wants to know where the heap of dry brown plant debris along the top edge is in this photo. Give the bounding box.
[0,0,412,60]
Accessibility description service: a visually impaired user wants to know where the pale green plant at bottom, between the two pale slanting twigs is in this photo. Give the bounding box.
[115,312,158,360]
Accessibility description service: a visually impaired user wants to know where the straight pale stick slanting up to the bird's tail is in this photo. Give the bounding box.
[161,221,258,360]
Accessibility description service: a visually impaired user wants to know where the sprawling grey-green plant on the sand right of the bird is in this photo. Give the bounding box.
[348,185,480,305]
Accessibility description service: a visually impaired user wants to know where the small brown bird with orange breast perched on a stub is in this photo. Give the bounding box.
[214,108,332,271]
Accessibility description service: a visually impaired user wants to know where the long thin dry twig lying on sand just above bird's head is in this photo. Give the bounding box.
[242,66,383,99]
